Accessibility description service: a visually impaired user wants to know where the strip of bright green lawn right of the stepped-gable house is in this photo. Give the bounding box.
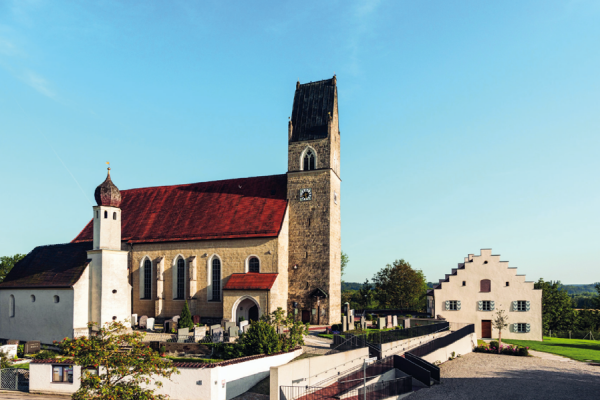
[502,336,600,362]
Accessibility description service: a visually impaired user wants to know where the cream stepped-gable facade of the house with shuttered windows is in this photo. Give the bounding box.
[428,249,542,340]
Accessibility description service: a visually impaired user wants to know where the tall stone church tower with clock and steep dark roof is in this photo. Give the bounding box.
[287,76,342,325]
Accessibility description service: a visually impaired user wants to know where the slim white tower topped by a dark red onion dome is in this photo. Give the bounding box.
[88,168,131,325]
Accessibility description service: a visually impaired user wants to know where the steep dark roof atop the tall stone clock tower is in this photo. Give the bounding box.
[291,78,337,142]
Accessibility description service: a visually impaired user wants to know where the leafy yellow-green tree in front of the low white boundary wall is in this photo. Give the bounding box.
[60,322,179,400]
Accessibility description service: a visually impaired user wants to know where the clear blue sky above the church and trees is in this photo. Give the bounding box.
[0,0,600,284]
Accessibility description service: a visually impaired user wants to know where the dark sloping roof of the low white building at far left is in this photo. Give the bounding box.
[0,242,92,289]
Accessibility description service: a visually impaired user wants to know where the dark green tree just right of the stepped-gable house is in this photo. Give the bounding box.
[534,278,575,333]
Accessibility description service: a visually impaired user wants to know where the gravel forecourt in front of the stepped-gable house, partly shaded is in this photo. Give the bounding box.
[409,353,600,400]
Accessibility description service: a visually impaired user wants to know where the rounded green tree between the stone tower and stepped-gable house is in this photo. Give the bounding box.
[373,260,427,311]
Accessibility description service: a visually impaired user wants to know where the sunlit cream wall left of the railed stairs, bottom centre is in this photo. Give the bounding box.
[270,348,369,400]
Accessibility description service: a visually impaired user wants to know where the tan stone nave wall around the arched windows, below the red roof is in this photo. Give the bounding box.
[131,238,287,318]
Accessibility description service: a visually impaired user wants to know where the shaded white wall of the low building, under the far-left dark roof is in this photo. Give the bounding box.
[0,289,74,344]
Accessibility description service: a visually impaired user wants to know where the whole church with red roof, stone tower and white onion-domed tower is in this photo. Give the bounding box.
[0,76,341,343]
